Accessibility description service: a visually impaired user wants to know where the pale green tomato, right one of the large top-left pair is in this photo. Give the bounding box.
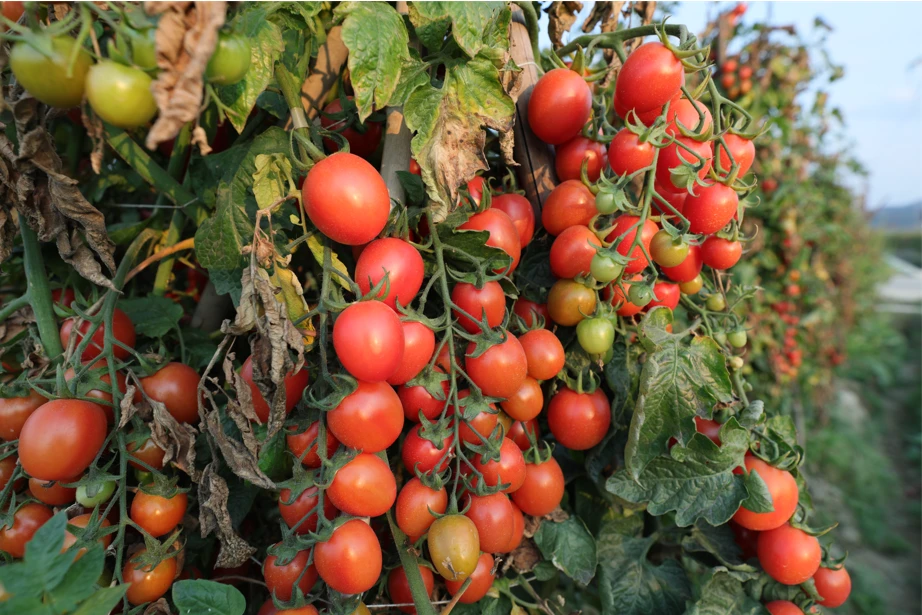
[86,61,157,128]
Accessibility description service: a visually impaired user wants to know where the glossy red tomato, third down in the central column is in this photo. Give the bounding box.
[333,301,404,382]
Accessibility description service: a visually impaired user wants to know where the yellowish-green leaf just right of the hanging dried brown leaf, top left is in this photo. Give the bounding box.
[215,3,285,133]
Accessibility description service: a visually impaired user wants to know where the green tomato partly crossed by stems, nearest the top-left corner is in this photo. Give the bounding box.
[10,36,93,109]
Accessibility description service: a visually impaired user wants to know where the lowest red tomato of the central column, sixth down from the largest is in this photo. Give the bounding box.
[314,519,381,594]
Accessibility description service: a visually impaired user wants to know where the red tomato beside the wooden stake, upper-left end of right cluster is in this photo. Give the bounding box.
[528,68,588,145]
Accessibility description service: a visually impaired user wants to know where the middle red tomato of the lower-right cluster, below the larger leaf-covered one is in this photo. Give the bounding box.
[757,523,823,585]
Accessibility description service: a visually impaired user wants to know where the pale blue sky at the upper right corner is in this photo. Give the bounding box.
[542,2,922,209]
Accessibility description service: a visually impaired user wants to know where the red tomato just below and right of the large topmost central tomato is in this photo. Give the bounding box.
[355,237,423,310]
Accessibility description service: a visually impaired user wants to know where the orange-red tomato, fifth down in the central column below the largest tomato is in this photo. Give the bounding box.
[326,453,397,517]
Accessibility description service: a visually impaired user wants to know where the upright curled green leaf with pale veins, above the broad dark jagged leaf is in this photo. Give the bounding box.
[625,308,733,480]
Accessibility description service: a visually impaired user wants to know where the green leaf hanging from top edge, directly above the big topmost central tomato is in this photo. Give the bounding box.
[334,2,410,121]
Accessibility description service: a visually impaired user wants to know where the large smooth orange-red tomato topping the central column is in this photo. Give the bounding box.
[301,152,391,246]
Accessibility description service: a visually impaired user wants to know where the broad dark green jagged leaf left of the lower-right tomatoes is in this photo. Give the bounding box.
[605,419,749,527]
